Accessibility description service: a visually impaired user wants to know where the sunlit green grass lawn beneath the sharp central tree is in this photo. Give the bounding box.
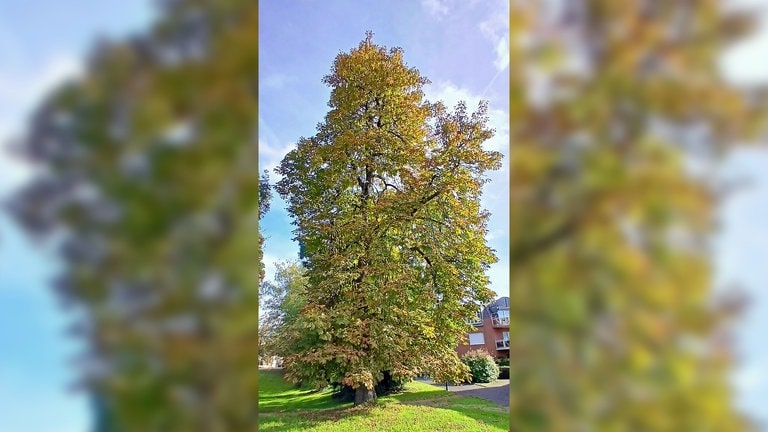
[259,370,509,432]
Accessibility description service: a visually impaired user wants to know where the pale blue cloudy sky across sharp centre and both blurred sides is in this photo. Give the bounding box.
[0,0,768,432]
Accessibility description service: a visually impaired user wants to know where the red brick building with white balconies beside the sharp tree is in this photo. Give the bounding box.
[456,297,509,358]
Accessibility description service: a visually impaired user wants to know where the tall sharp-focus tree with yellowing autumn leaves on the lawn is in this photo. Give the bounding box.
[276,33,501,404]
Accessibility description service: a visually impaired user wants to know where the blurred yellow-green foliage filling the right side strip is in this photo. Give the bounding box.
[510,0,766,432]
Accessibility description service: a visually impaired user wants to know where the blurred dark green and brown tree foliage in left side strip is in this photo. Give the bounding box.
[6,0,265,432]
